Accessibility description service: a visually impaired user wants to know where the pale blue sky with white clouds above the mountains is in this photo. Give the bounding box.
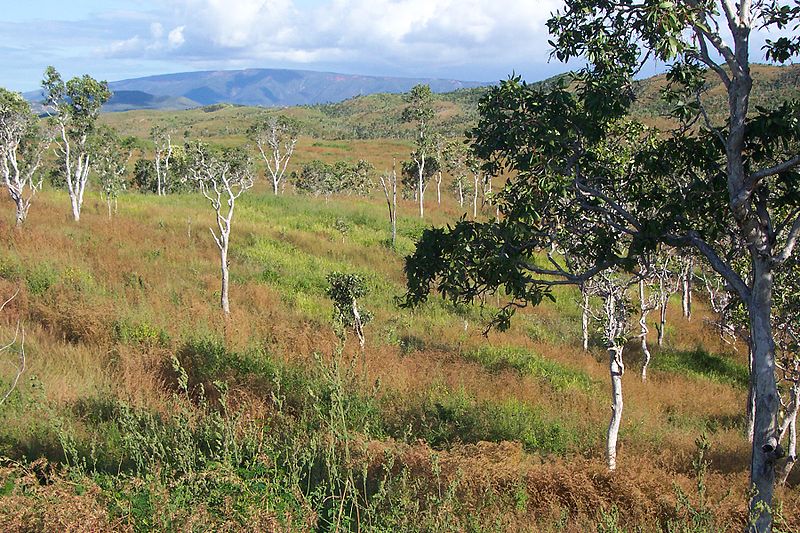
[0,0,788,90]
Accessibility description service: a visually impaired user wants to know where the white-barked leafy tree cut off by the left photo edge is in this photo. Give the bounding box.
[0,88,49,226]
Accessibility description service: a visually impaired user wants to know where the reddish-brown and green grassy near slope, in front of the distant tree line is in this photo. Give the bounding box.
[0,186,796,530]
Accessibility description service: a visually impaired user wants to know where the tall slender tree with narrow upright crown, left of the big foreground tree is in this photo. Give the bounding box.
[402,84,435,218]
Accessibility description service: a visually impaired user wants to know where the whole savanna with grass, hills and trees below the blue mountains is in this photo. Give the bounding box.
[0,1,800,532]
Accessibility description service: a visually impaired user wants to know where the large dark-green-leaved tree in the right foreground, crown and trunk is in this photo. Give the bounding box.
[406,0,800,532]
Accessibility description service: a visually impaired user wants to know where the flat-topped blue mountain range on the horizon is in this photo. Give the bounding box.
[25,69,488,111]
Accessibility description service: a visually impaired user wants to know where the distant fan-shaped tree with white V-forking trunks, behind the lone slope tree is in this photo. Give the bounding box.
[248,115,299,195]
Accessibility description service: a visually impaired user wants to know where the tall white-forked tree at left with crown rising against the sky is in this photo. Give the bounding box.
[42,67,111,222]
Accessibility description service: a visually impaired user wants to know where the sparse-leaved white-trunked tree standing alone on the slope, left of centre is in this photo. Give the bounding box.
[187,142,254,316]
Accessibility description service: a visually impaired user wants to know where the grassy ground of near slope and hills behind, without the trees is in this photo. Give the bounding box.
[0,63,800,532]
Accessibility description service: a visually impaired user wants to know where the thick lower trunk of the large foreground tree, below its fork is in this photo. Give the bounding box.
[748,251,782,532]
